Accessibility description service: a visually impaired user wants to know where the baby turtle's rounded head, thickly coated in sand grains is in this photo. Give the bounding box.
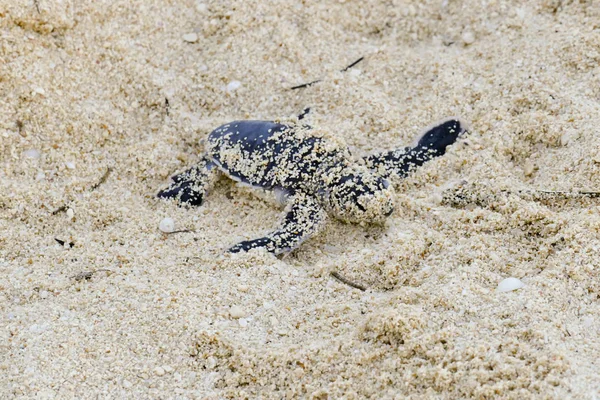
[319,166,394,223]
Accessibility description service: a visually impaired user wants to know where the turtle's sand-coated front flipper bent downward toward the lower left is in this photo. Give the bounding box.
[229,193,327,254]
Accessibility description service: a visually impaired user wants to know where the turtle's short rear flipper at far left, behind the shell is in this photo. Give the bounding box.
[157,157,219,206]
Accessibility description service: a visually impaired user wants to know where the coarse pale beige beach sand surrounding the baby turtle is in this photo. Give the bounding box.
[0,0,600,399]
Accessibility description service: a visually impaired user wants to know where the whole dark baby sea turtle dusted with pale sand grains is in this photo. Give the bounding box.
[158,118,465,254]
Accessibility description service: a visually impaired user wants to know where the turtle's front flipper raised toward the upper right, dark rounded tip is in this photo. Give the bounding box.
[364,118,466,178]
